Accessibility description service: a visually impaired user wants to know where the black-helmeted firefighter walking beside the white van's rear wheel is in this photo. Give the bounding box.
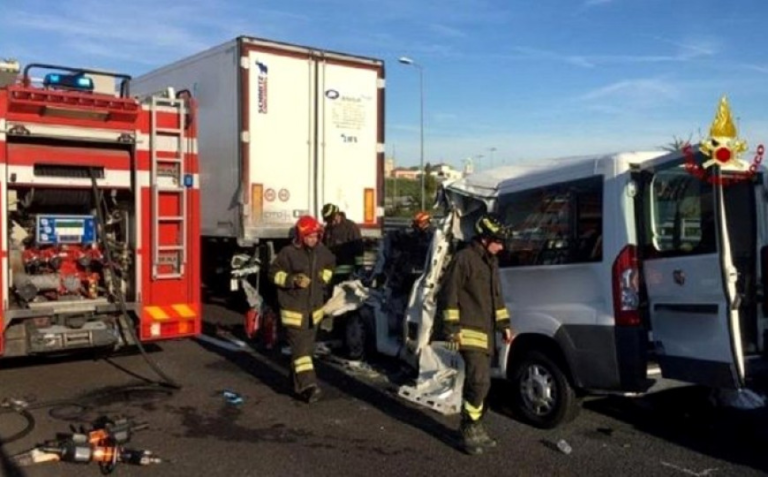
[441,214,512,455]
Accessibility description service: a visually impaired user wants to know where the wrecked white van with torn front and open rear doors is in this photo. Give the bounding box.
[414,148,768,428]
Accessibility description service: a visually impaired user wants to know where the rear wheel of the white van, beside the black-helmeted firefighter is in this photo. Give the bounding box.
[510,351,581,429]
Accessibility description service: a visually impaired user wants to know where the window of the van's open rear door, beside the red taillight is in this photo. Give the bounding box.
[645,167,717,257]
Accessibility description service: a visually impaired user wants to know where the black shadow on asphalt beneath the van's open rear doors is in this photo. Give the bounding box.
[583,386,768,472]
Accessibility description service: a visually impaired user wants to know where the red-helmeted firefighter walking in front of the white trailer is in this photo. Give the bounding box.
[269,216,336,403]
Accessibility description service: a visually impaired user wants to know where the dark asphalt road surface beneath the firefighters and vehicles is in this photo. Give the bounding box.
[0,306,768,477]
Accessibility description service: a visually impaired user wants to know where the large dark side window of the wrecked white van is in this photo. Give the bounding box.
[498,176,603,267]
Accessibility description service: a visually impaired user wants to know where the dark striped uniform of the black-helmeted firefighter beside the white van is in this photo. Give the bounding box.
[442,241,509,421]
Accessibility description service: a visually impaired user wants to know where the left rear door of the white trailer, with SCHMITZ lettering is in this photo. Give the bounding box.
[243,45,316,237]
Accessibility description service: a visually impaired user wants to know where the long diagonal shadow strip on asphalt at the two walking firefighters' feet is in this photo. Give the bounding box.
[197,323,458,448]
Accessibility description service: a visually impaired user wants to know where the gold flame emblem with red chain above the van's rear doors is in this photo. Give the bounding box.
[683,96,765,185]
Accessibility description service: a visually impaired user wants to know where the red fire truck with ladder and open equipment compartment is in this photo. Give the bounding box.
[0,61,201,357]
